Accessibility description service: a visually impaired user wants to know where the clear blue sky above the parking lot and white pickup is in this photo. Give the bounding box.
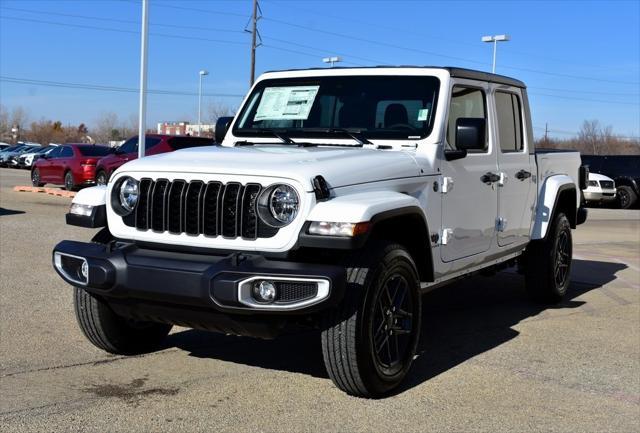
[0,0,640,138]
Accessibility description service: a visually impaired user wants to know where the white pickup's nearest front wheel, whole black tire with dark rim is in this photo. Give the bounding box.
[321,243,422,398]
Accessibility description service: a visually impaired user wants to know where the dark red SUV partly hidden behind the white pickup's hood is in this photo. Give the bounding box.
[96,134,214,185]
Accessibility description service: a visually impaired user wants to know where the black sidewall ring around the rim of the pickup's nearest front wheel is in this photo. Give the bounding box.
[358,249,422,395]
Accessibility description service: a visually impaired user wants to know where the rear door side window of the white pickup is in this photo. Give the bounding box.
[496,92,523,152]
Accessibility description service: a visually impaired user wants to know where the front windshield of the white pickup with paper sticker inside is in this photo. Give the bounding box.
[233,76,440,139]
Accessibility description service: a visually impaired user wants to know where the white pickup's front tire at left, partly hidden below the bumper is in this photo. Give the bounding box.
[74,287,171,355]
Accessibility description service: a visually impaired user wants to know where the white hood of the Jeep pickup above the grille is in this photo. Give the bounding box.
[118,145,420,191]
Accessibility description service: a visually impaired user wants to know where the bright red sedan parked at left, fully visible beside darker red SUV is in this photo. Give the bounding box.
[31,144,111,191]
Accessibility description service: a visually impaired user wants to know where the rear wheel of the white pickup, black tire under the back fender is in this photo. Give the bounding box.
[524,212,573,303]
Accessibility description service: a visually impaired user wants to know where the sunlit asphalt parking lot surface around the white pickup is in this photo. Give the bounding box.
[0,169,640,432]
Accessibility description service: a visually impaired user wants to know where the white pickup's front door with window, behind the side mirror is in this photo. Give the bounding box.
[440,84,498,262]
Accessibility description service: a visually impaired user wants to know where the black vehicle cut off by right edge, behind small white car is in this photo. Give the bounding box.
[582,155,640,209]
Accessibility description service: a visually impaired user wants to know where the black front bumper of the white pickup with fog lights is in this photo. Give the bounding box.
[53,241,346,315]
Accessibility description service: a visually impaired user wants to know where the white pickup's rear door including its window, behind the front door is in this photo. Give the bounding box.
[493,86,536,247]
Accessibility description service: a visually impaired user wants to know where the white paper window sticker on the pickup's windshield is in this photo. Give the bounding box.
[253,86,320,121]
